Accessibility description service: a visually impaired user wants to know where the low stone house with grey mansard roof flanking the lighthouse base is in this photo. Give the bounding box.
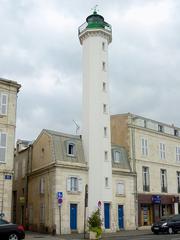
[14,129,135,234]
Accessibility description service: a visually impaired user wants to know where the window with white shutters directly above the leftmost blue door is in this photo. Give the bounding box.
[67,176,82,192]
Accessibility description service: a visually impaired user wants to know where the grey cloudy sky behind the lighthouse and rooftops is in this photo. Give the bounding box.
[0,0,180,140]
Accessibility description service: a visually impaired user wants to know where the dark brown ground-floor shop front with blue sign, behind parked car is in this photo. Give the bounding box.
[138,194,179,226]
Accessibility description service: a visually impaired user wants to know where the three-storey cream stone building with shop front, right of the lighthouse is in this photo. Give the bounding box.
[111,113,180,226]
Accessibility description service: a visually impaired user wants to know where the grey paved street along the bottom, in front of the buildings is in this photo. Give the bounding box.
[26,230,180,240]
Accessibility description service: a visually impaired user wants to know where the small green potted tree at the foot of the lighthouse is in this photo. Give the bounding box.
[88,209,102,239]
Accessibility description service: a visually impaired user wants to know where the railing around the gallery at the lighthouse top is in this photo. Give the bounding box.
[78,22,112,34]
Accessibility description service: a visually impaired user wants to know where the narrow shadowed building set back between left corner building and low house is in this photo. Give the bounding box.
[12,140,32,226]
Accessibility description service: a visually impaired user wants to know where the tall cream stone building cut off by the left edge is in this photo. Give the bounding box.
[0,78,21,220]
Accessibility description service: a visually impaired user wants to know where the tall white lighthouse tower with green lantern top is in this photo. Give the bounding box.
[79,10,112,225]
